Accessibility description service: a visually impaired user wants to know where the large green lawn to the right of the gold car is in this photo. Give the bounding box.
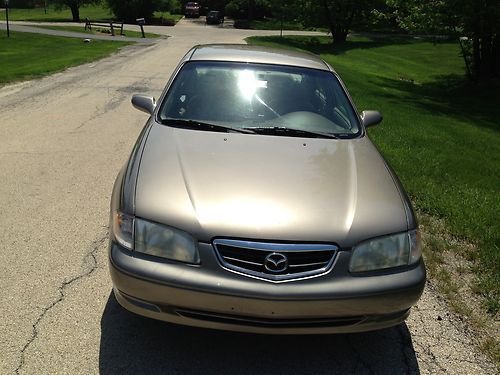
[248,37,500,316]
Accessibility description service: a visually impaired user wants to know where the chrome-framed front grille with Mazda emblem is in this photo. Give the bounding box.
[213,239,337,281]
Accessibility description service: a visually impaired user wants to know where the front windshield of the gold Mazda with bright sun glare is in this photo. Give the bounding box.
[159,62,360,138]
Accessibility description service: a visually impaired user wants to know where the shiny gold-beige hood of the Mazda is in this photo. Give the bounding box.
[135,124,408,247]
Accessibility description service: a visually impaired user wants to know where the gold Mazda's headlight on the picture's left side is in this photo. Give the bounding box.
[134,218,200,264]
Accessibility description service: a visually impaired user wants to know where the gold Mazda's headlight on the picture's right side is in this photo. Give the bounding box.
[349,230,422,272]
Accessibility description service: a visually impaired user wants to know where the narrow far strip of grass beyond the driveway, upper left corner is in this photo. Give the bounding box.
[5,5,114,22]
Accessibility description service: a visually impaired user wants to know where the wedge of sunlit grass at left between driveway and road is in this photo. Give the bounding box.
[0,31,130,85]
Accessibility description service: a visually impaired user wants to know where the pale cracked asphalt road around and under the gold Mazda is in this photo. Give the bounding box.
[0,16,495,374]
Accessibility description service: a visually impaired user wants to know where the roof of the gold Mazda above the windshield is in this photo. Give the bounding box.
[188,44,331,71]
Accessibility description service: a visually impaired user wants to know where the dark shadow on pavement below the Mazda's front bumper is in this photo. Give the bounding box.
[99,293,419,375]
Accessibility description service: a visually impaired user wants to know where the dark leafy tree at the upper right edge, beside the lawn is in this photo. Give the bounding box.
[387,0,500,82]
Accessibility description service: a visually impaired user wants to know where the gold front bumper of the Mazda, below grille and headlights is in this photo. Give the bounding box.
[109,242,426,334]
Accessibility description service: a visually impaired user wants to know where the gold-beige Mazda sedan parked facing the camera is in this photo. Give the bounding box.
[109,45,426,334]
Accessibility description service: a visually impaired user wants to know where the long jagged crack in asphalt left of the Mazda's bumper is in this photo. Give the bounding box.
[15,231,108,374]
